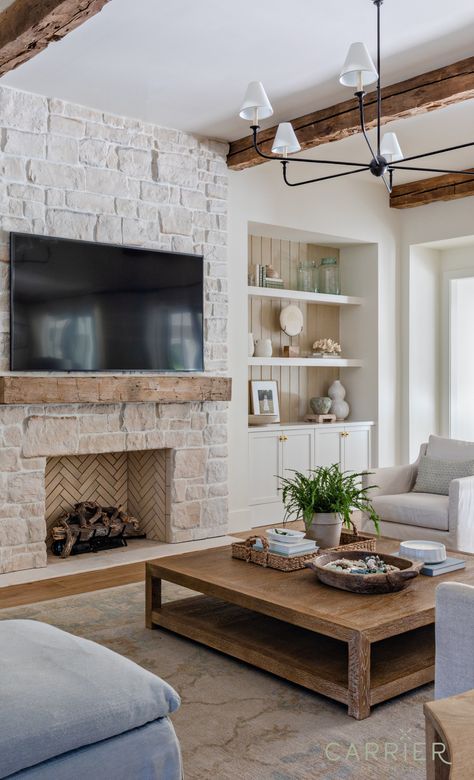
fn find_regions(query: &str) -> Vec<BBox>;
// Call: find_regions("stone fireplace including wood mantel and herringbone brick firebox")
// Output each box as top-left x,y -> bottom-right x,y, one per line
0,375 -> 230,573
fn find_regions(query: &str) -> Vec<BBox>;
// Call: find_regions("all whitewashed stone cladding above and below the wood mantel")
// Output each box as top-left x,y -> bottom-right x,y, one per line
0,88 -> 228,571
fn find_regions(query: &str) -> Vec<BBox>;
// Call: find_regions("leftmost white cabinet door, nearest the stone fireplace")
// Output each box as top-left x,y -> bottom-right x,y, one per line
249,431 -> 282,504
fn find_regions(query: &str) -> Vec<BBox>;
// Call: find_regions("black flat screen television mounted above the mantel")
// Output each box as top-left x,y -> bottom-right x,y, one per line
10,233 -> 203,371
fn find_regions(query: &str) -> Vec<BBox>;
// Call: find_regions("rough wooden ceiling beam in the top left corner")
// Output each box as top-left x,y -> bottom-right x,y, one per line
0,0 -> 109,76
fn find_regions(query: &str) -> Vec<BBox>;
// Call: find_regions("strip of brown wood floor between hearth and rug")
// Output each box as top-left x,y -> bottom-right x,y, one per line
0,561 -> 145,609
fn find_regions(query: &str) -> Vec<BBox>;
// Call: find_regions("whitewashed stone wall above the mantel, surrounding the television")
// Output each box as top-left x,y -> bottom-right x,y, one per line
0,87 -> 228,372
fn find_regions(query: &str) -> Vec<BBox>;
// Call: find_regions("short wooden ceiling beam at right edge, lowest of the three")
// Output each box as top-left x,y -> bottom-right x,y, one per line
390,168 -> 474,209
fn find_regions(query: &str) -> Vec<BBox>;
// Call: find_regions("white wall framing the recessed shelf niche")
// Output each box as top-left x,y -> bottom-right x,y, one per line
228,163 -> 400,528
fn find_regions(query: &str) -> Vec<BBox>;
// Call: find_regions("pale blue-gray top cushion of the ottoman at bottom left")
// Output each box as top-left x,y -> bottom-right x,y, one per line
0,620 -> 180,778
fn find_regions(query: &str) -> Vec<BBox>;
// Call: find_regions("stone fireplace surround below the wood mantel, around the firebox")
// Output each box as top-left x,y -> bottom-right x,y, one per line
0,401 -> 228,572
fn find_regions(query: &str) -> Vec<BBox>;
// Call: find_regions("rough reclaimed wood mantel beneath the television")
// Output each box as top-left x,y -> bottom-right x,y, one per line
0,374 -> 232,404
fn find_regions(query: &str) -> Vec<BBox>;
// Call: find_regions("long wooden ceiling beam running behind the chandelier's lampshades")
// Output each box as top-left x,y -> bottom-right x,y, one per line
227,57 -> 474,170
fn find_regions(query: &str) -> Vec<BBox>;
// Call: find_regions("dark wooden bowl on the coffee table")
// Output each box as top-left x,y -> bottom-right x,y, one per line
306,550 -> 423,594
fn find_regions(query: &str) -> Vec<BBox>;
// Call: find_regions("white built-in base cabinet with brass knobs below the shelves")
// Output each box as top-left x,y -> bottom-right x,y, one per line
249,422 -> 373,525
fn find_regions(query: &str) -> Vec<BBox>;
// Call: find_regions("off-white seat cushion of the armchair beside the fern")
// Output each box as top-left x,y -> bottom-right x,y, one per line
371,493 -> 449,531
